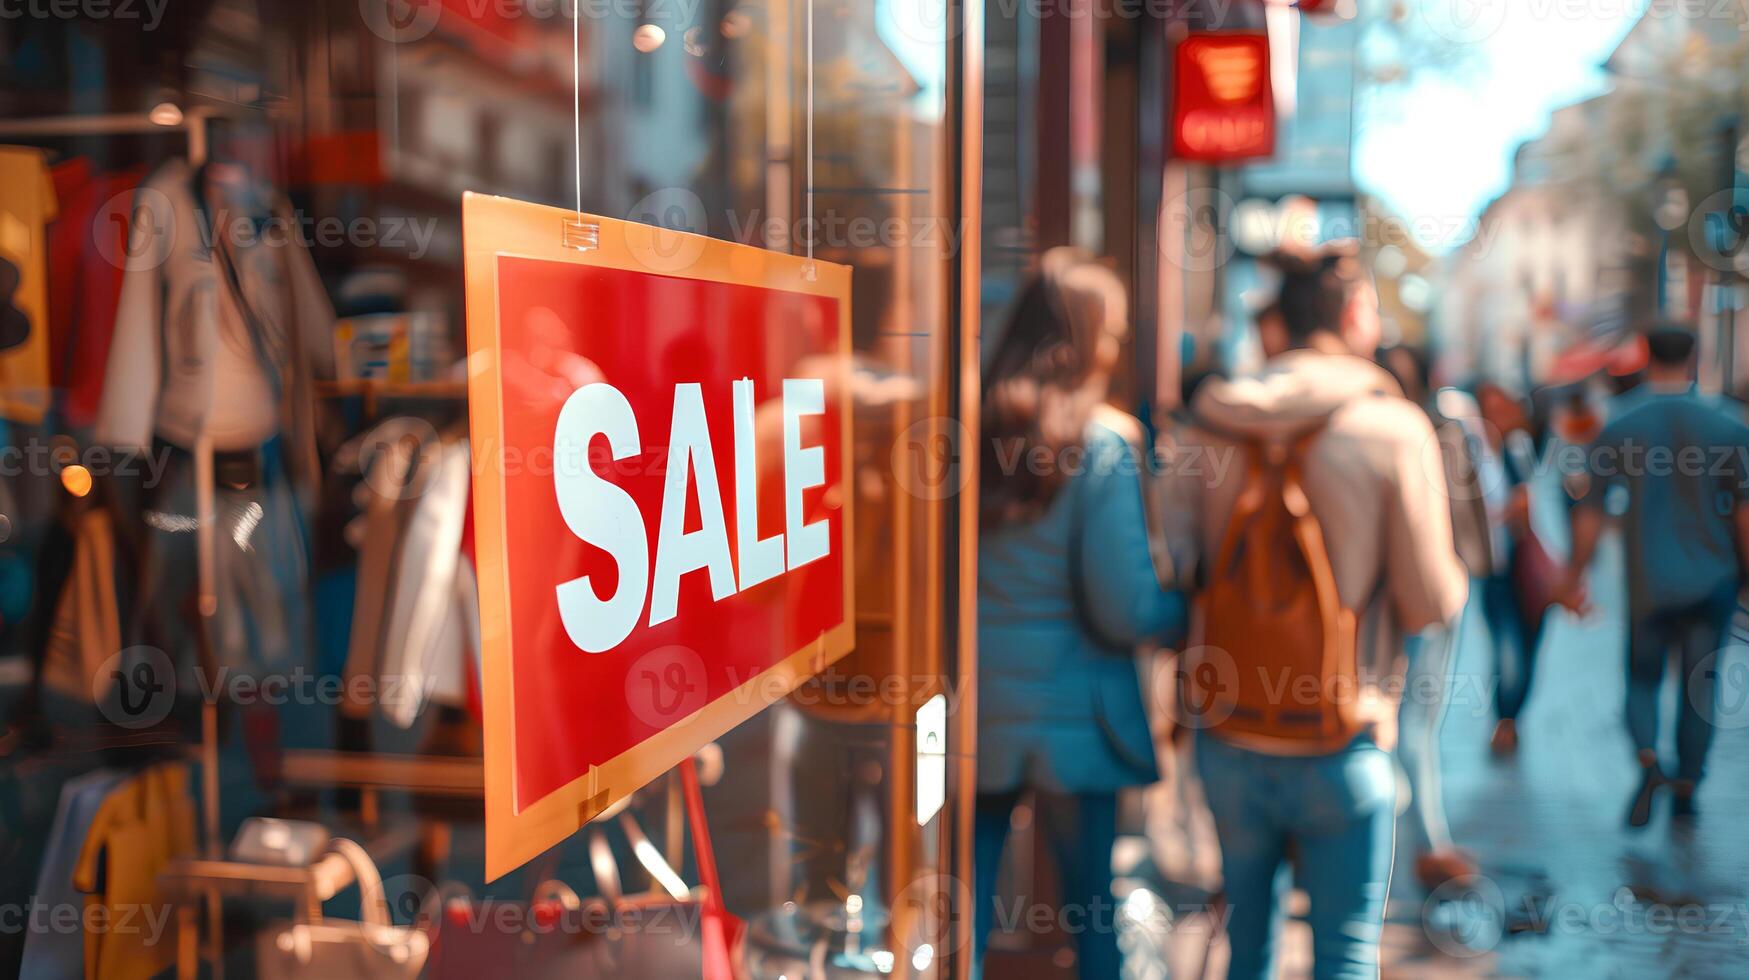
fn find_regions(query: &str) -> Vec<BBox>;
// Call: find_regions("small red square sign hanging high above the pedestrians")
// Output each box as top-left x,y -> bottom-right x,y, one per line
1172,32 -> 1275,163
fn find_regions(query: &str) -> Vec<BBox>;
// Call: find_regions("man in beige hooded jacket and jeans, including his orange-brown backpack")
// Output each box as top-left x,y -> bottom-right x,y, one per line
1184,245 -> 1469,980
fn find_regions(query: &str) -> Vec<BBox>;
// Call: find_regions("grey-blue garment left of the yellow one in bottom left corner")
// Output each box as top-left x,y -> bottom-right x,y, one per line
19,768 -> 128,980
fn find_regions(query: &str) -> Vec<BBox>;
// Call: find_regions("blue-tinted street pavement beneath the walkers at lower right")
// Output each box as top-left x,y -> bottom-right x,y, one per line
1385,541 -> 1749,978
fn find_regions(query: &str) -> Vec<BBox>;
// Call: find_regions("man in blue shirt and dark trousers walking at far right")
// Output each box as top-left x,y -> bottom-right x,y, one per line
1558,324 -> 1749,828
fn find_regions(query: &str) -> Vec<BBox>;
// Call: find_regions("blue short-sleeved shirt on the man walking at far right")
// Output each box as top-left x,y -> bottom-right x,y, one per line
1588,389 -> 1749,614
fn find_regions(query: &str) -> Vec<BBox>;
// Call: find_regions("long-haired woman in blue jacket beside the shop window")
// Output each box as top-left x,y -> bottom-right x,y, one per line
974,249 -> 1184,980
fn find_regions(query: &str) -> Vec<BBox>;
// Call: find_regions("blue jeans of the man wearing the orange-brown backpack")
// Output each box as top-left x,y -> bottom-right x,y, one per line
1196,732 -> 1397,980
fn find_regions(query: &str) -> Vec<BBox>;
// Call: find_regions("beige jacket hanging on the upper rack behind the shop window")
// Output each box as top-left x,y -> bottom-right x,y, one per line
96,159 -> 334,497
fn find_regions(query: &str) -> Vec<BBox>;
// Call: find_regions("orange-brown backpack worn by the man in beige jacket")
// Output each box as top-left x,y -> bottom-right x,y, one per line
1186,431 -> 1362,756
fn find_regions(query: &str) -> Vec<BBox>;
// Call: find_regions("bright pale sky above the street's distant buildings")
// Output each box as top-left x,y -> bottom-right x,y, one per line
1354,0 -> 1644,249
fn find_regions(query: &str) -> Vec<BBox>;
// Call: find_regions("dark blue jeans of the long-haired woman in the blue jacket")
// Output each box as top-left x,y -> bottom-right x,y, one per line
972,789 -> 1123,980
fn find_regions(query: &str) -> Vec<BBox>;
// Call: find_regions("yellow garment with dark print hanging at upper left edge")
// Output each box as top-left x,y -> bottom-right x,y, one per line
0,147 -> 54,424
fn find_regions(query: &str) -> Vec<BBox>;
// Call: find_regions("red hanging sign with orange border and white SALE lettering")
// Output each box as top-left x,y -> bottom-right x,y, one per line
463,194 -> 854,877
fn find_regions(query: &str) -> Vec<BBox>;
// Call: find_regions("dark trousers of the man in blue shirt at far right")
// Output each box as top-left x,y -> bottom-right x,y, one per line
1627,581 -> 1737,782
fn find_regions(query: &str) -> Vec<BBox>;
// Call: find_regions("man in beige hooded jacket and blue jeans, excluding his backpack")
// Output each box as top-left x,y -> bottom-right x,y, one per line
1177,249 -> 1469,980
